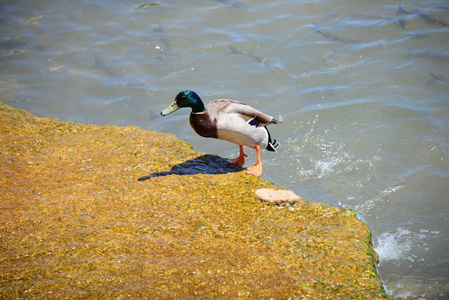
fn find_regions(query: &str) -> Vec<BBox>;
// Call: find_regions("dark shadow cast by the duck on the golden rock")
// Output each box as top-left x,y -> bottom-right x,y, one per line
138,154 -> 243,181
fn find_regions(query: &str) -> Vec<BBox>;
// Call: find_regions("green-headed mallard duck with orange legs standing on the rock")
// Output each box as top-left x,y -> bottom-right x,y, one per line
161,90 -> 281,176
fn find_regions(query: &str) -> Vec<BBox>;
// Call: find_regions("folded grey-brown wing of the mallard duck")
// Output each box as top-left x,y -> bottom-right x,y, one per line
207,99 -> 281,126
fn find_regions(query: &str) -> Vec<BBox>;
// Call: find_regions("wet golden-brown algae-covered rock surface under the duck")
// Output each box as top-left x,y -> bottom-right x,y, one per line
0,104 -> 386,299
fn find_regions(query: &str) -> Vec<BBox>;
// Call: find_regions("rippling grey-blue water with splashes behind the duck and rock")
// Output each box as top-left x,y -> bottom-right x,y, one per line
0,0 -> 449,299
